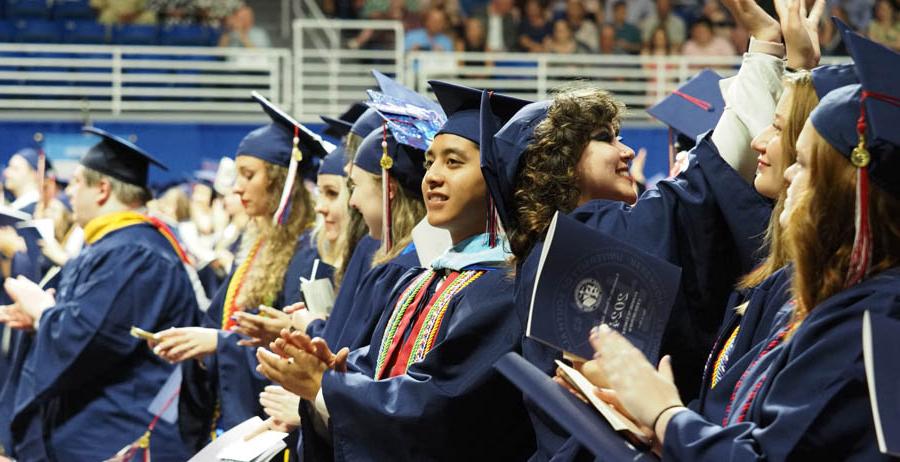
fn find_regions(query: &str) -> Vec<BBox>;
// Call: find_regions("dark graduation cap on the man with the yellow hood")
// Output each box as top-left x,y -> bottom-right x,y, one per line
81,127 -> 169,188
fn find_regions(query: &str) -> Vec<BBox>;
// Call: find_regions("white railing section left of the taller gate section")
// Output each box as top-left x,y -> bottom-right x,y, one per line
0,44 -> 293,121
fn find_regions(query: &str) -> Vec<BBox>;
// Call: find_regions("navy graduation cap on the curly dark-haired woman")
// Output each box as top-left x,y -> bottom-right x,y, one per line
479,91 -> 551,244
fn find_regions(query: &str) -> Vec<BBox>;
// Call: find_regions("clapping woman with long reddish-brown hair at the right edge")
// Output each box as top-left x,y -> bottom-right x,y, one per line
585,27 -> 900,461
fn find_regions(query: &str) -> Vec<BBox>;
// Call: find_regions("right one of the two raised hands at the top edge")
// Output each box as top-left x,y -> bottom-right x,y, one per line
775,0 -> 825,69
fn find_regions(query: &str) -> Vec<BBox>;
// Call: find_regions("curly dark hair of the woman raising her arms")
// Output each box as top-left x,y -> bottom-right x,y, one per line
507,83 -> 624,260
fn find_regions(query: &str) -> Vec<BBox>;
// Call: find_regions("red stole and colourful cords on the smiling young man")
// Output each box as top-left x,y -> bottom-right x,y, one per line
375,269 -> 485,379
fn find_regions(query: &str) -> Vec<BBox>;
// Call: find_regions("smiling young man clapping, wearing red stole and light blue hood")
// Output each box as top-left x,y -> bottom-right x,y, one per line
259,82 -> 533,460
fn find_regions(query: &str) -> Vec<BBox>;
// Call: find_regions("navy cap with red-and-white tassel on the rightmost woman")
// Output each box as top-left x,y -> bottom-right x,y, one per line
810,20 -> 900,286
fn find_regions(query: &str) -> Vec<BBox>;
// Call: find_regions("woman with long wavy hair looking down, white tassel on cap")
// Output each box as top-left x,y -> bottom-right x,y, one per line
151,96 -> 331,447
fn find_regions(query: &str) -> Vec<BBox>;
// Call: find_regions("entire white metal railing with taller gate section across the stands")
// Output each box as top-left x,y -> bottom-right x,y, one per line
0,19 -> 848,123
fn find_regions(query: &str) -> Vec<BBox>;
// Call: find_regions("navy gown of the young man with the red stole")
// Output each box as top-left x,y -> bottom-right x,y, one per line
322,268 -> 533,461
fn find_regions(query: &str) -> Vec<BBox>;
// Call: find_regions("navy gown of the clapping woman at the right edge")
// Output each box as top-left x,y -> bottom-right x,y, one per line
663,268 -> 900,461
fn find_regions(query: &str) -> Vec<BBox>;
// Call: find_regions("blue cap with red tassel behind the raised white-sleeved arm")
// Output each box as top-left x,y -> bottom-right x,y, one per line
647,69 -> 725,140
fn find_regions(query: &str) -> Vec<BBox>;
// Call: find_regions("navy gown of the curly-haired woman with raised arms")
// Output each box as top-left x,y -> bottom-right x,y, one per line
516,133 -> 772,460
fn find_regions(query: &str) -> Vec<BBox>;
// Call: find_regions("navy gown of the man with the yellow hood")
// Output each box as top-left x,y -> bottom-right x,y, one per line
12,220 -> 198,461
